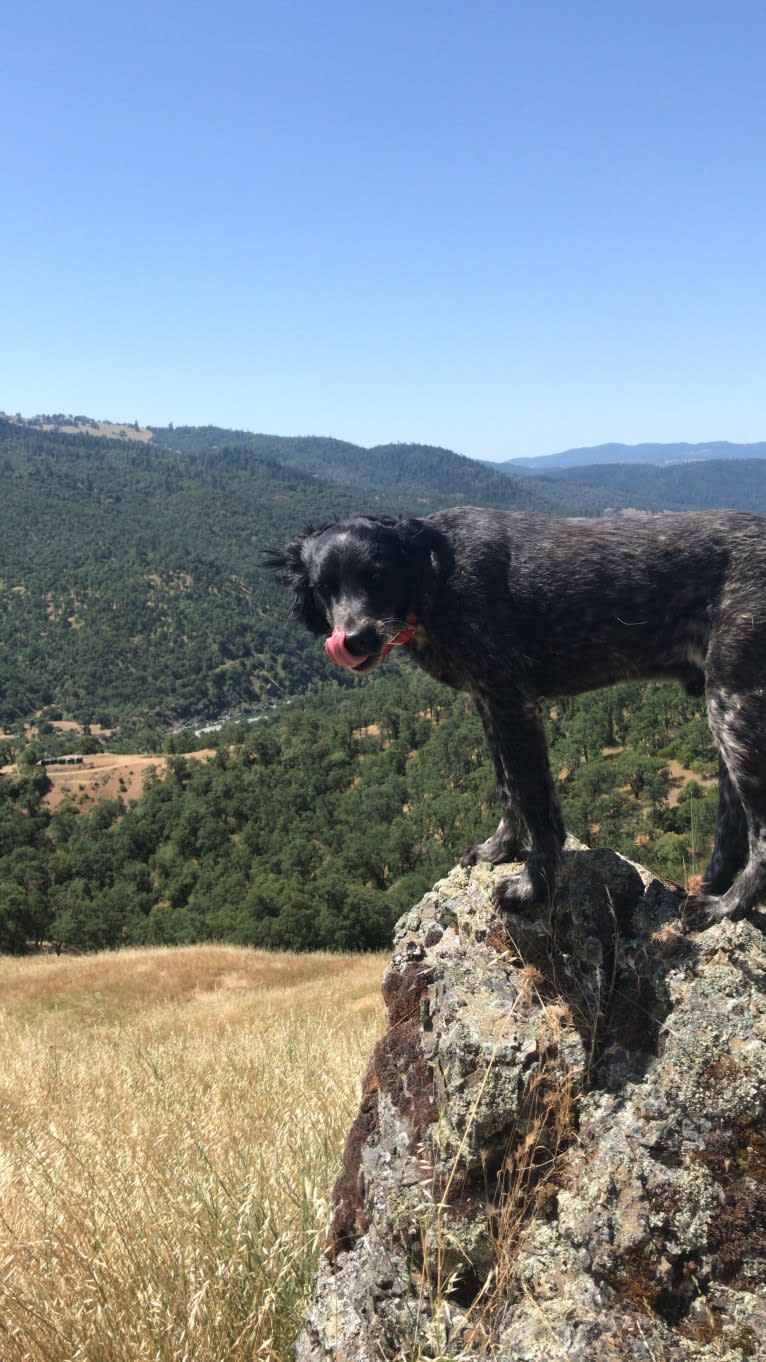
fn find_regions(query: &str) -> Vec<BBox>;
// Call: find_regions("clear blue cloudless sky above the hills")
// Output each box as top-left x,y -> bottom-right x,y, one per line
0,0 -> 766,459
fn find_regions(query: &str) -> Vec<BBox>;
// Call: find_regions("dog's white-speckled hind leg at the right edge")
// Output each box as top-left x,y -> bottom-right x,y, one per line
705,685 -> 766,922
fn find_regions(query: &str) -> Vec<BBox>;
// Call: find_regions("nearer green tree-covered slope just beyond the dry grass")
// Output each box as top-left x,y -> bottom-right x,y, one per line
0,658 -> 716,951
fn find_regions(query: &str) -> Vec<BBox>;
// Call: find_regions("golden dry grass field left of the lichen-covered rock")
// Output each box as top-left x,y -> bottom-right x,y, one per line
0,947 -> 383,1362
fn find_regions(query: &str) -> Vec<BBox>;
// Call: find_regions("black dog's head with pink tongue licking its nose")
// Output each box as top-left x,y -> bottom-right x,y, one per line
266,515 -> 442,676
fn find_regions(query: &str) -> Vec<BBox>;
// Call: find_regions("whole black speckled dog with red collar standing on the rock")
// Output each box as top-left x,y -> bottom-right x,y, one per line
267,507 -> 766,921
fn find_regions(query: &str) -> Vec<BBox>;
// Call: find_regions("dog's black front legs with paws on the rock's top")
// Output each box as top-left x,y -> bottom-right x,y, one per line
463,696 -> 566,910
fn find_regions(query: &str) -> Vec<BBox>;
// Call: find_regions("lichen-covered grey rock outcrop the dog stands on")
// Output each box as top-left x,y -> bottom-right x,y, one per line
297,849 -> 766,1362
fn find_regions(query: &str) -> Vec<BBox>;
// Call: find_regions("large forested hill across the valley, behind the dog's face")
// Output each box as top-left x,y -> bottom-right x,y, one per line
0,421 -> 561,731
